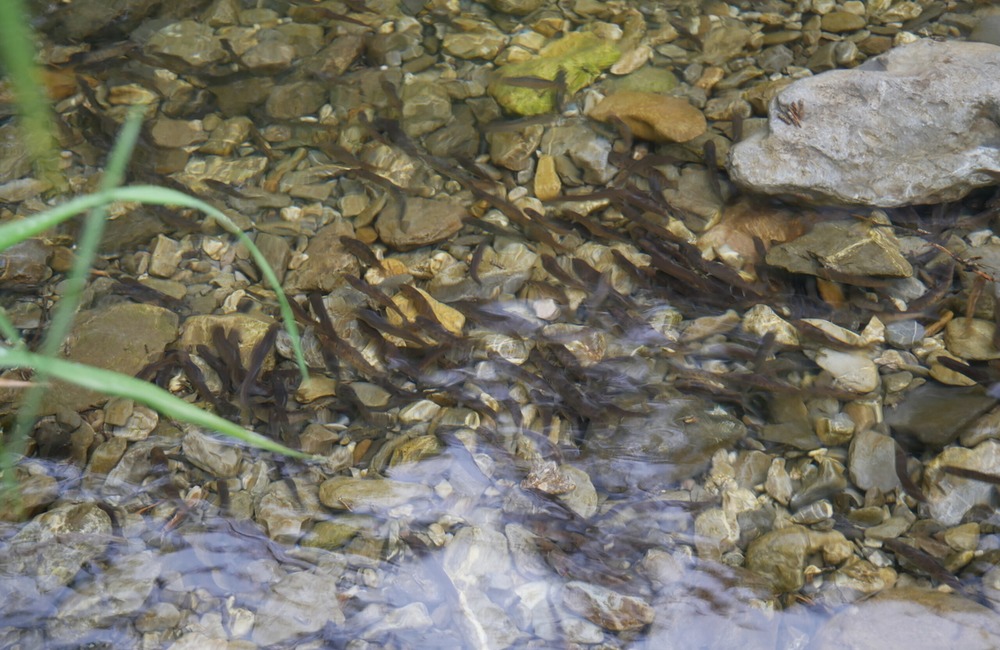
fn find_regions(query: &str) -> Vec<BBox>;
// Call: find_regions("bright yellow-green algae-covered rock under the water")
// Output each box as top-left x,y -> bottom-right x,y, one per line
488,32 -> 621,115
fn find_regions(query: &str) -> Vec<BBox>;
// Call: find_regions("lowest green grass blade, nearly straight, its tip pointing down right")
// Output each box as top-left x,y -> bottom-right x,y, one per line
0,348 -> 310,458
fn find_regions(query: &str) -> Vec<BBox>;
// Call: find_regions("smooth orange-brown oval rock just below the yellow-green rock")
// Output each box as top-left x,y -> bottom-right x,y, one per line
590,91 -> 706,142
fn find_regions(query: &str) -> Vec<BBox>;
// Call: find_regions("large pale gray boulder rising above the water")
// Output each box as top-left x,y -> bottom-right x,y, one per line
729,40 -> 1000,207
